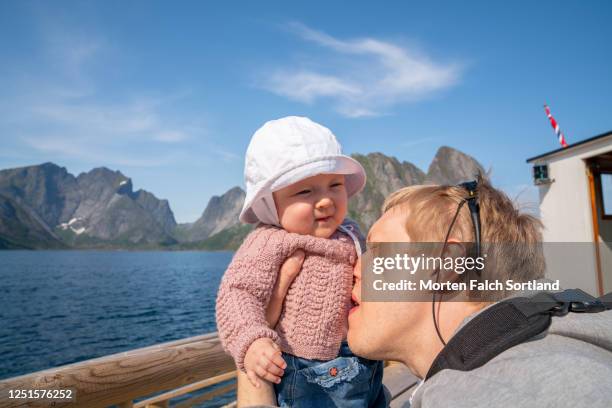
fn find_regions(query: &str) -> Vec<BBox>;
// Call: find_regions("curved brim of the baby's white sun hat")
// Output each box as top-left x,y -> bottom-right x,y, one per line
240,155 -> 366,224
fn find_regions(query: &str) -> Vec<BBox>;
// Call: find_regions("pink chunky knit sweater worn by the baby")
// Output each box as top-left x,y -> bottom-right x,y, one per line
216,224 -> 358,370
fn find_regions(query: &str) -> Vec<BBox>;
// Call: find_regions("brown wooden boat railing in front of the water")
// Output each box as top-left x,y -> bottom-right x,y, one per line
0,333 -> 415,408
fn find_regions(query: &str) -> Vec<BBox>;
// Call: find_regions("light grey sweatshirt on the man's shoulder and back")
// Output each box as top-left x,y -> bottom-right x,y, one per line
414,311 -> 612,408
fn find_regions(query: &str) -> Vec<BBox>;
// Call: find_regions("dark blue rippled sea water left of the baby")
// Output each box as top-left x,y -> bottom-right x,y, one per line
0,251 -> 233,404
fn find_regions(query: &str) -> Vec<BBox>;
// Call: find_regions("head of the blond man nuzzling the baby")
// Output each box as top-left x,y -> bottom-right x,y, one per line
348,180 -> 544,375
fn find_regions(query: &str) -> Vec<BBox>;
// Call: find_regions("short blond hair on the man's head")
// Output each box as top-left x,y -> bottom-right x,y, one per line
382,176 -> 545,294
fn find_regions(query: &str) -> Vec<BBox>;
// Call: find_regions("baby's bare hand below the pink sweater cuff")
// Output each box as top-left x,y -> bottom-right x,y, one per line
244,337 -> 287,388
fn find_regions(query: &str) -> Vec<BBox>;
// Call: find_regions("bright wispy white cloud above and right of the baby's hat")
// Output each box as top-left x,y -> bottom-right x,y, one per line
259,23 -> 462,117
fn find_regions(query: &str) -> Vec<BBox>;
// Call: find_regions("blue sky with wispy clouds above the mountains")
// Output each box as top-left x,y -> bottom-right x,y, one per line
0,0 -> 612,222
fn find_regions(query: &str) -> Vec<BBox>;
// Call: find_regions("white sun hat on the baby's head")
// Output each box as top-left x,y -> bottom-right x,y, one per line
240,116 -> 366,226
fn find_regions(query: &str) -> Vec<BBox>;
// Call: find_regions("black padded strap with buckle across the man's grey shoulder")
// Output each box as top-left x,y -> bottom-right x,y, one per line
425,289 -> 612,380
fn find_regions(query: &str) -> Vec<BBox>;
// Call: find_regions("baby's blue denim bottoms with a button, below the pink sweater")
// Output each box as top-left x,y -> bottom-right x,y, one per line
274,341 -> 387,408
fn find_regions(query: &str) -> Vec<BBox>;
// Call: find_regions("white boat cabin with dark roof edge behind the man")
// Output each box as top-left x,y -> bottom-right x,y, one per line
527,131 -> 612,296
